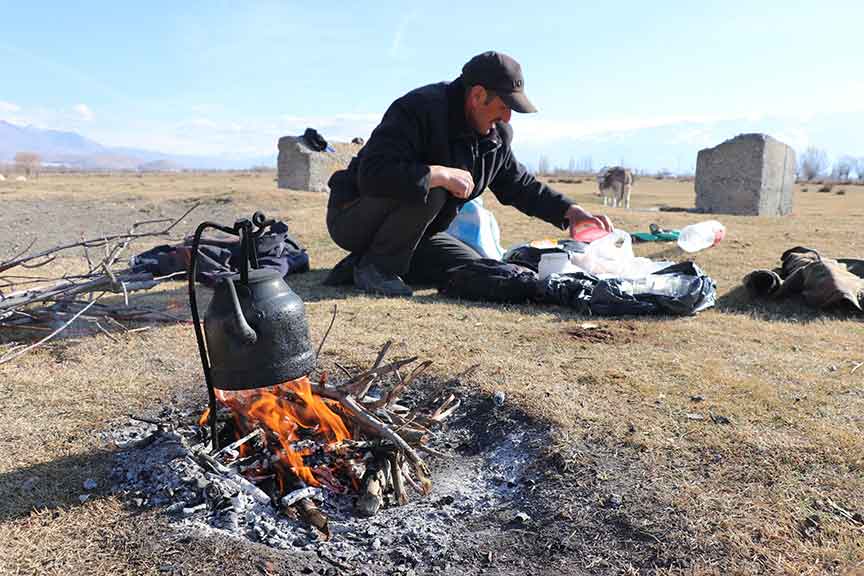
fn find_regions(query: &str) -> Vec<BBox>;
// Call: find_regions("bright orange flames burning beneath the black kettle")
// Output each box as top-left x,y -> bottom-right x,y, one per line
211,376 -> 351,492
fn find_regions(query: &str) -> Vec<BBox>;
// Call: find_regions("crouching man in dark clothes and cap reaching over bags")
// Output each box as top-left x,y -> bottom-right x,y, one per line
325,52 -> 612,296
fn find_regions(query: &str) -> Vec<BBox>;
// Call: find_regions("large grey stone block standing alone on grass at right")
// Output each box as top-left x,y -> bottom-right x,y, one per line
696,134 -> 796,216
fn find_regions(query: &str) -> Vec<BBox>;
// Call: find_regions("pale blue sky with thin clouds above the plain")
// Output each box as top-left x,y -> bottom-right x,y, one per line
0,0 -> 864,170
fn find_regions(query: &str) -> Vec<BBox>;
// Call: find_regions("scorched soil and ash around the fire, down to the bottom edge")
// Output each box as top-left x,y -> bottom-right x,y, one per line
105,382 -> 695,575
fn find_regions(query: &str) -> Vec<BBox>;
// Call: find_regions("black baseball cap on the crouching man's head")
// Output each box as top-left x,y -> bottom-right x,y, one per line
462,50 -> 537,112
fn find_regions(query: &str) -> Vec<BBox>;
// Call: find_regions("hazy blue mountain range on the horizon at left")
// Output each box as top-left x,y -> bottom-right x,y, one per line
0,120 -> 276,171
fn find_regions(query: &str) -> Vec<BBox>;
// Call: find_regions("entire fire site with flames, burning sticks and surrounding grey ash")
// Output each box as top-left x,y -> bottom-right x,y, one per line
109,356 -> 545,574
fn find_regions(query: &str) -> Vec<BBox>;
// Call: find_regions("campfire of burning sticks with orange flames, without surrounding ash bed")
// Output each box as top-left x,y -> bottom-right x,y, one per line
188,342 -> 460,539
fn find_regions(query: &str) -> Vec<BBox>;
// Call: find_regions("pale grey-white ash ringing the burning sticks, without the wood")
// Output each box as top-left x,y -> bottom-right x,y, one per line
106,401 -> 548,571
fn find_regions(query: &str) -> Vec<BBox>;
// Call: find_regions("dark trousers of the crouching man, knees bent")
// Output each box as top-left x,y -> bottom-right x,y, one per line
327,188 -> 482,284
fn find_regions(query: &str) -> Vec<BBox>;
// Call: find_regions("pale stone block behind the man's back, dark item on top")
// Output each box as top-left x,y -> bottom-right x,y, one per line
277,136 -> 360,192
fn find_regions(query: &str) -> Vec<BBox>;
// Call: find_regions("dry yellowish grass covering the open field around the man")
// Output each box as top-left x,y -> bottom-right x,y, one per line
0,174 -> 864,574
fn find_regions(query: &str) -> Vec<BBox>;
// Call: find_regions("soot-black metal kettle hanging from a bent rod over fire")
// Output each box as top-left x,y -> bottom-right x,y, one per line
189,212 -> 316,446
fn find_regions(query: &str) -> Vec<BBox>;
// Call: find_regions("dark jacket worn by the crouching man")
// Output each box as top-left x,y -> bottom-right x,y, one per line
330,77 -> 572,236
